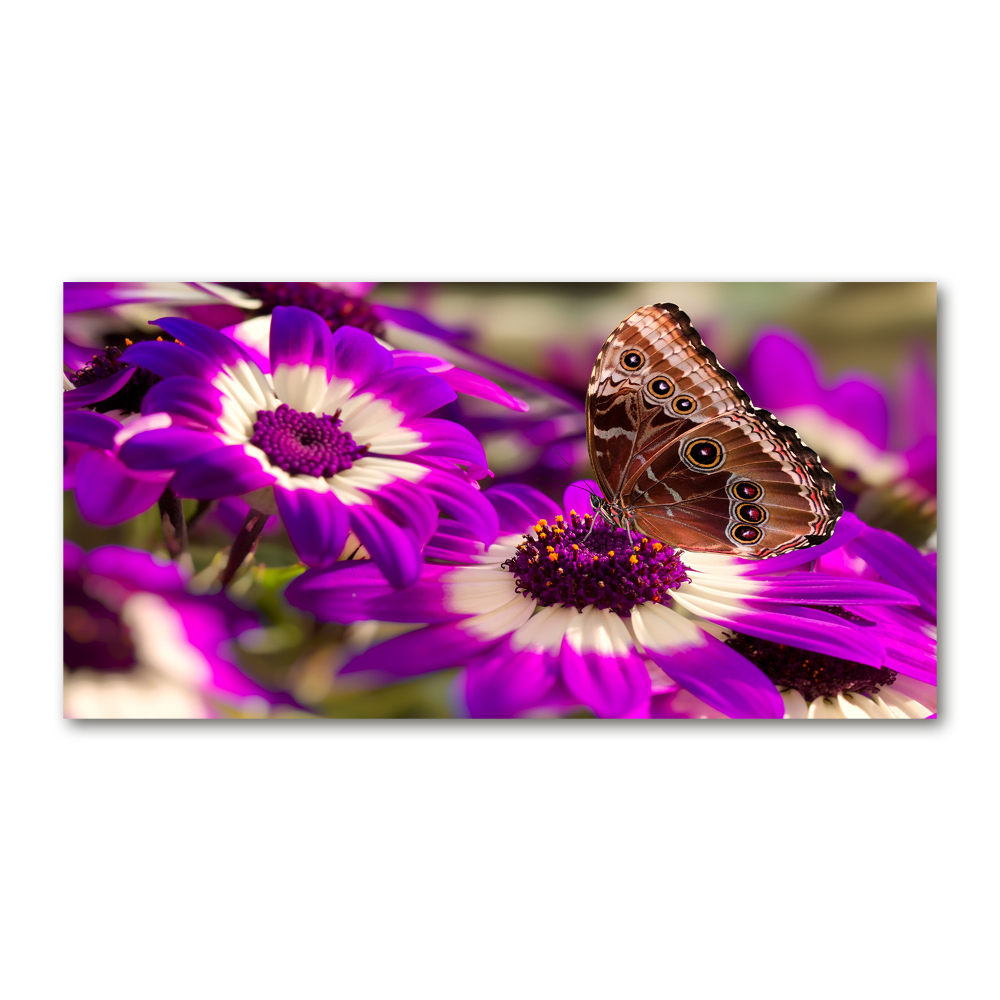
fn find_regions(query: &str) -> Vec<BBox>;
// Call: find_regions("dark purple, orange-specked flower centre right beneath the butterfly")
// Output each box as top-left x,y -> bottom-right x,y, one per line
503,511 -> 688,615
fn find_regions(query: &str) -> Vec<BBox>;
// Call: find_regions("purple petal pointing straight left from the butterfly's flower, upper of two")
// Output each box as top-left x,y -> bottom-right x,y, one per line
285,560 -> 454,625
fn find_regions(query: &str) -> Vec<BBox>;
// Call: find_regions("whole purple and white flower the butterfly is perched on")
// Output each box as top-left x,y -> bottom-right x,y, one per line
286,483 -> 915,718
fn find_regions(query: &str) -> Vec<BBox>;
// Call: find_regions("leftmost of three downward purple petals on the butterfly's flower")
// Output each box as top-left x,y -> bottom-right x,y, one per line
463,642 -> 559,719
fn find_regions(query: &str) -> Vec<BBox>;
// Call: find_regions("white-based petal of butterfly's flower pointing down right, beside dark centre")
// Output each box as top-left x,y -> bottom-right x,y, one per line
632,607 -> 785,719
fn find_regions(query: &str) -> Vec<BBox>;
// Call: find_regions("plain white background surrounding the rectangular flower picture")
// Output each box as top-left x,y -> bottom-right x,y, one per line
7,0 -> 1000,998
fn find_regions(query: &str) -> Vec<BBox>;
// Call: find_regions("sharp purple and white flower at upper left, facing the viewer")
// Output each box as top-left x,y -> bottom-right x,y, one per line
119,306 -> 497,586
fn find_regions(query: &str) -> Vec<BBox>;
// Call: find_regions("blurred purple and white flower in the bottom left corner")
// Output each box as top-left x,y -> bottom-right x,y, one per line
63,542 -> 294,719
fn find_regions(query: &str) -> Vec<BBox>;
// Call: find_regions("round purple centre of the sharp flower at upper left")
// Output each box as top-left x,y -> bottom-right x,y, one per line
250,403 -> 368,479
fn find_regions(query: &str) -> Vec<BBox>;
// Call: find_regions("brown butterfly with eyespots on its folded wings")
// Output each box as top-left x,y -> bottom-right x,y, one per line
587,303 -> 844,558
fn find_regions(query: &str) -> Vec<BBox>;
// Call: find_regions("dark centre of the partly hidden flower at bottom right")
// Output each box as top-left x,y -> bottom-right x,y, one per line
728,608 -> 896,701
